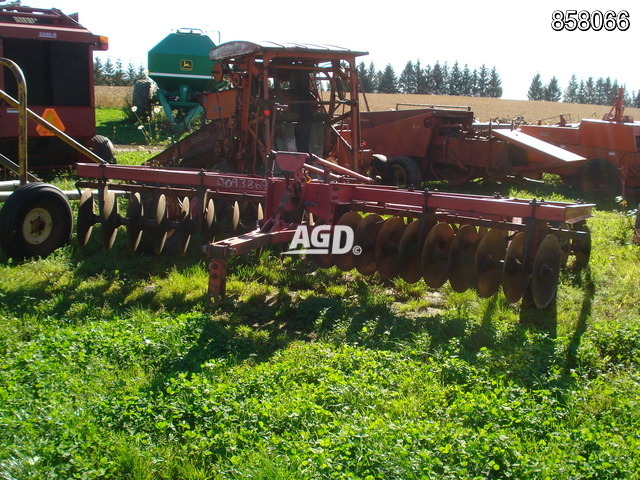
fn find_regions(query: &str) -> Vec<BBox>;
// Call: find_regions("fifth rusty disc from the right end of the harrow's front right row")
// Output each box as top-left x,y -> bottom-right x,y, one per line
421,222 -> 455,288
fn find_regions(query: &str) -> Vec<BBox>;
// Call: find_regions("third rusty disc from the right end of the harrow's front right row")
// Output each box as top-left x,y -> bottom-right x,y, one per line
474,229 -> 507,298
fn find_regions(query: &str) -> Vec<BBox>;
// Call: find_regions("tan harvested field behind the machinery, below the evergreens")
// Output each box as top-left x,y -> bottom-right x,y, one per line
95,86 -> 640,123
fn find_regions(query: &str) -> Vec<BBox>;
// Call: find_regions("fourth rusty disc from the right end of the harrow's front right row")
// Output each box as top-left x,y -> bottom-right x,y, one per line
448,225 -> 480,292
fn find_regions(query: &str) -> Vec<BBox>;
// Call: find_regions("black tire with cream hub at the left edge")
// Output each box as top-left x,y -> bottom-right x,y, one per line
0,182 -> 73,259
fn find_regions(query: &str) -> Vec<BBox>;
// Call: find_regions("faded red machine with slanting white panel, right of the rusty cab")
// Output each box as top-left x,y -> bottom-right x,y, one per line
361,106 -> 584,185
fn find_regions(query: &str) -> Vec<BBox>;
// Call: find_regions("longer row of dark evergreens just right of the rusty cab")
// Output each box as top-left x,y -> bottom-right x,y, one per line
356,60 -> 502,98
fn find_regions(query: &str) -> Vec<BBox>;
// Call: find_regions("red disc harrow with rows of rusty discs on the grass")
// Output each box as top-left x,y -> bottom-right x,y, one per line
77,152 -> 592,308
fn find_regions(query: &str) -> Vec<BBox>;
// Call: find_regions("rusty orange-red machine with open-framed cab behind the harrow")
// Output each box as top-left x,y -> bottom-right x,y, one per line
149,41 -> 371,178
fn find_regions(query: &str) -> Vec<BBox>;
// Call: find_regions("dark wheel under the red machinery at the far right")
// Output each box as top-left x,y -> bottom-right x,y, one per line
576,159 -> 622,203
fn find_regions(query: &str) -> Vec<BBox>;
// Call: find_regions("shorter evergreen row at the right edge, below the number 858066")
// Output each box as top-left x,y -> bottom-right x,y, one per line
527,73 -> 640,107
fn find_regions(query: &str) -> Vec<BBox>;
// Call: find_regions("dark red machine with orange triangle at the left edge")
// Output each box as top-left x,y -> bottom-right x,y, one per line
0,4 -> 113,169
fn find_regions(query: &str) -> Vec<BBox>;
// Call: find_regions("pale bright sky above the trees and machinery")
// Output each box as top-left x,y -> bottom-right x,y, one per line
17,0 -> 640,99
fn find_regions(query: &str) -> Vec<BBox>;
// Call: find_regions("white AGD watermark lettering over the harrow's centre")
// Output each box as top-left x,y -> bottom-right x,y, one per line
283,225 -> 362,255
